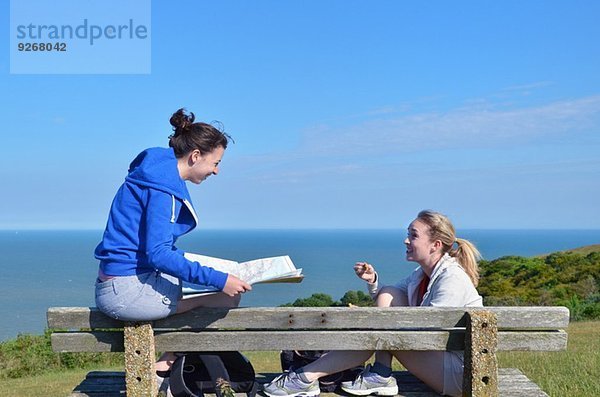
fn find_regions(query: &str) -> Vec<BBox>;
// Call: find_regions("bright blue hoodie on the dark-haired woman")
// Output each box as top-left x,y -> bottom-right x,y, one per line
95,148 -> 227,290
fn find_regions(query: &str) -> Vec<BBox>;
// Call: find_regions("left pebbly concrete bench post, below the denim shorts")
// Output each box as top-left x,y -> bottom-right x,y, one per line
124,323 -> 157,397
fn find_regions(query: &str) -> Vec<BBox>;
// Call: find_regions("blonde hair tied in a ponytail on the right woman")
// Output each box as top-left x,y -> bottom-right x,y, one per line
417,210 -> 481,287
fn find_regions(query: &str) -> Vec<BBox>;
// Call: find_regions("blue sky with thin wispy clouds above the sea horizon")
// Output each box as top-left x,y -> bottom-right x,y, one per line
0,0 -> 600,229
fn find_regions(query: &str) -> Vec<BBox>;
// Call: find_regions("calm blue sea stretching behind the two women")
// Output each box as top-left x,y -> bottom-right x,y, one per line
0,230 -> 600,341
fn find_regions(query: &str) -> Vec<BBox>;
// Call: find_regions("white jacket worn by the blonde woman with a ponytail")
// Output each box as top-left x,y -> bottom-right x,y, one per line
367,253 -> 483,307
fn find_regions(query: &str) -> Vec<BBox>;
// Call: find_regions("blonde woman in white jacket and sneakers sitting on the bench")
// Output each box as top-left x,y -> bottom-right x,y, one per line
264,211 -> 482,397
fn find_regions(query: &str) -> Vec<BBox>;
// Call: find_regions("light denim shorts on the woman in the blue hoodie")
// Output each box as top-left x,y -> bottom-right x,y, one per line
96,271 -> 182,321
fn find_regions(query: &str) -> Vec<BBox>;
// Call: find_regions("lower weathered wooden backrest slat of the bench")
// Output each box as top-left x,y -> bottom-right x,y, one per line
52,330 -> 567,352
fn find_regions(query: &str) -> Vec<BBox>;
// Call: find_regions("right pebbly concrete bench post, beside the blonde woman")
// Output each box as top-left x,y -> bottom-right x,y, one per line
463,310 -> 498,397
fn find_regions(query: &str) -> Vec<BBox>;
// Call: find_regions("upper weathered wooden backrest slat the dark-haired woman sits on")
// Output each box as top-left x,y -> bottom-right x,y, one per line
48,307 -> 569,330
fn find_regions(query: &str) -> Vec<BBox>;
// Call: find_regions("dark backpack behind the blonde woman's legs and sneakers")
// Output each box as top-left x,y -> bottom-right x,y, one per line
279,350 -> 364,393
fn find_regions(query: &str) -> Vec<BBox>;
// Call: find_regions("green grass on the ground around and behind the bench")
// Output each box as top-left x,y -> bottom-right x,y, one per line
0,321 -> 600,397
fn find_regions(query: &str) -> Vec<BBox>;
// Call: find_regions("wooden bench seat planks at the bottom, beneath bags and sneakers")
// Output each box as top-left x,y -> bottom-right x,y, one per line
71,368 -> 548,397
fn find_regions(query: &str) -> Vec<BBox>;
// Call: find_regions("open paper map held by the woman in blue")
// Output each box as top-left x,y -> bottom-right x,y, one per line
183,252 -> 304,299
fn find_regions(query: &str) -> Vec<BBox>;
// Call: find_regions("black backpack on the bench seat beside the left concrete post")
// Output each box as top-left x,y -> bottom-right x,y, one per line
169,352 -> 258,397
